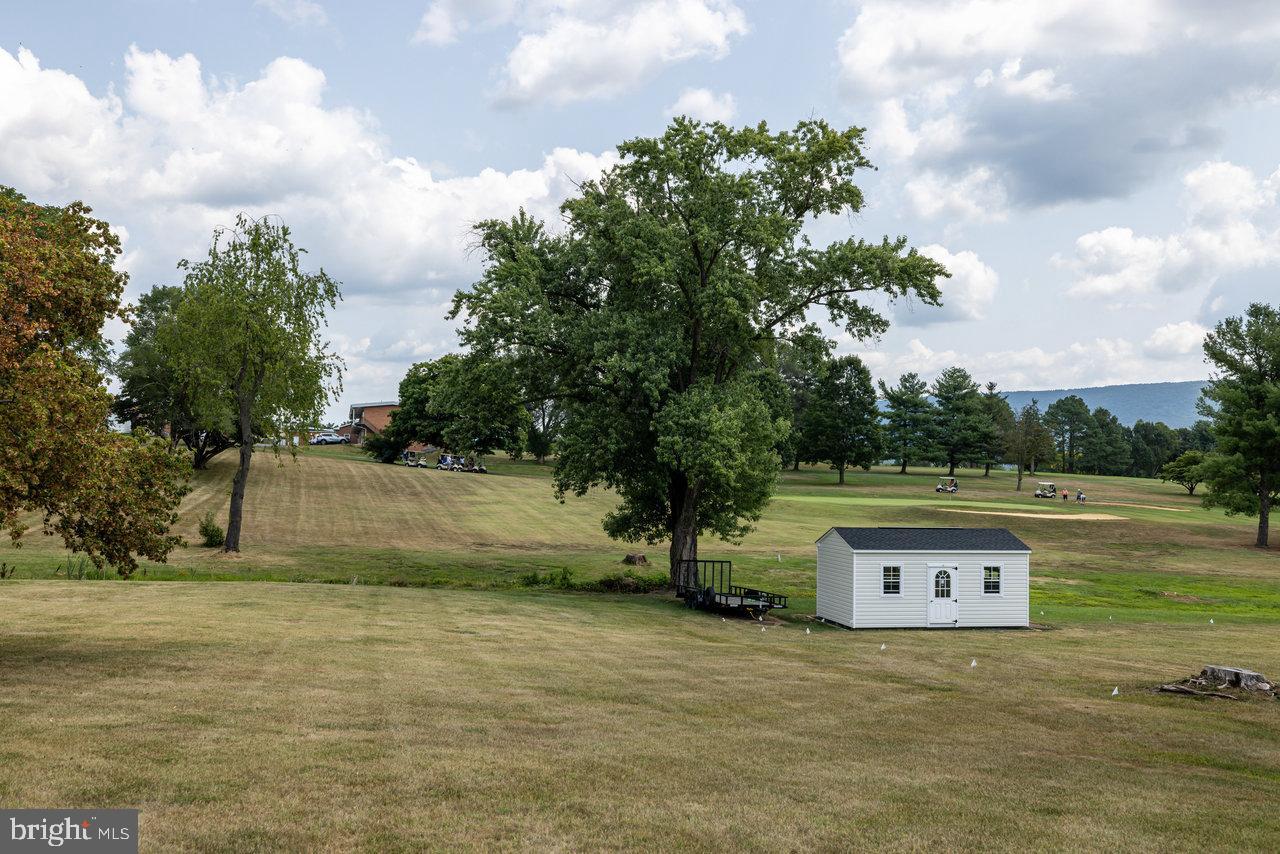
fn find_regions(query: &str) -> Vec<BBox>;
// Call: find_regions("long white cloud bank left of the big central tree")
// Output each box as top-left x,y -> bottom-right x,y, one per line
0,47 -> 616,297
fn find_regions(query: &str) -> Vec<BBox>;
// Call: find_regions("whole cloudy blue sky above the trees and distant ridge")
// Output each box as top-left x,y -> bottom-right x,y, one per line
0,0 -> 1280,421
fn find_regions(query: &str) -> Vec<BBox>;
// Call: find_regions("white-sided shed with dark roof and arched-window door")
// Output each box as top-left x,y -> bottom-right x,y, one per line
818,528 -> 1032,629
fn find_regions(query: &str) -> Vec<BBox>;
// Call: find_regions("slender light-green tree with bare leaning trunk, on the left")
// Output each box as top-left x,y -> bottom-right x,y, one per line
178,214 -> 342,552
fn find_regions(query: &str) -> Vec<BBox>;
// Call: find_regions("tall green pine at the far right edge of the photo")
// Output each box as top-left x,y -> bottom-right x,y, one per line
1199,302 -> 1280,548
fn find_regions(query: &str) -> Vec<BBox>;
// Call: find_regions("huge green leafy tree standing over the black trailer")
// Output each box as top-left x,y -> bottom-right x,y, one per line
453,119 -> 946,574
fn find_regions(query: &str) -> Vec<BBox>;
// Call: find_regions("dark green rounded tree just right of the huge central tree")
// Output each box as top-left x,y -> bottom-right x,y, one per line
803,356 -> 881,484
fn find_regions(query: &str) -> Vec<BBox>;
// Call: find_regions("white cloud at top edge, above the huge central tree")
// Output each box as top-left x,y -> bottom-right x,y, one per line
412,0 -> 748,104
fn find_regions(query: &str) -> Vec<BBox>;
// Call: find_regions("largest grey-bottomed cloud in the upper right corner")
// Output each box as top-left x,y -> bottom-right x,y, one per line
837,0 -> 1280,206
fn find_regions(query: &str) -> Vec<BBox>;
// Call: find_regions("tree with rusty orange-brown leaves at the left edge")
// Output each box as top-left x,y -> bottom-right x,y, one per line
0,187 -> 189,575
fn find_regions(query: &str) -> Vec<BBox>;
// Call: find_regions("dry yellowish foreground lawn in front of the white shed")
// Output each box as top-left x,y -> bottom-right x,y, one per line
0,581 -> 1280,851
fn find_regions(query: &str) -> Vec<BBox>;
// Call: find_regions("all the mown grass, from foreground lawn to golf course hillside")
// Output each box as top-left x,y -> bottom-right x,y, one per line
0,448 -> 1280,851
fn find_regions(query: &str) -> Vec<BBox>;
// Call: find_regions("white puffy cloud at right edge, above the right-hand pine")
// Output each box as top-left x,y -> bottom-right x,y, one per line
1053,161 -> 1280,296
